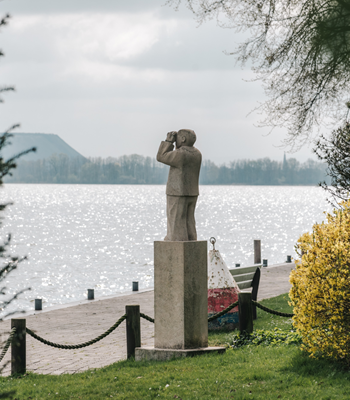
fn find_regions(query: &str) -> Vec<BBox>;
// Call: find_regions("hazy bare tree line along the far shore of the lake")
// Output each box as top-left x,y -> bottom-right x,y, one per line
5,154 -> 327,185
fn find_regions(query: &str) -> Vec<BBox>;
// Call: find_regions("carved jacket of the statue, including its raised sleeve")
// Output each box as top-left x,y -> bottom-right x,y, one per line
157,142 -> 202,196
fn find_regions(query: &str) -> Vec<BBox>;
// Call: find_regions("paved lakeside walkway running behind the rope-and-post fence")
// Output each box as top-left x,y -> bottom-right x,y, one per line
0,264 -> 294,375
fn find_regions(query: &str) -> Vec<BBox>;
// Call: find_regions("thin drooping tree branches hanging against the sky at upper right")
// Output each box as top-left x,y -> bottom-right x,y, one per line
167,0 -> 350,146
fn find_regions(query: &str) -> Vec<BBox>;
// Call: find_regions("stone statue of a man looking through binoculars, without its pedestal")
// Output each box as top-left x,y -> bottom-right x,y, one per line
157,129 -> 202,242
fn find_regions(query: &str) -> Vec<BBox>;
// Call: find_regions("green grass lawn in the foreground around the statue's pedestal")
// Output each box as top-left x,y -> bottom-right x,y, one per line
0,295 -> 350,400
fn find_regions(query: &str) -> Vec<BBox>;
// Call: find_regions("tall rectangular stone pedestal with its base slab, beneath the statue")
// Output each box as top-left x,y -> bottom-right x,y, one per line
135,241 -> 225,360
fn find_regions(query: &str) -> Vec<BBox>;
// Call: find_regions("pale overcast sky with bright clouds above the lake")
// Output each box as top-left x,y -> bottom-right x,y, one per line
0,0 -> 314,164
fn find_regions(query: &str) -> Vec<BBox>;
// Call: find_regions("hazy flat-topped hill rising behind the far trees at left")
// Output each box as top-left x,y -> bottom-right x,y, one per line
2,133 -> 85,161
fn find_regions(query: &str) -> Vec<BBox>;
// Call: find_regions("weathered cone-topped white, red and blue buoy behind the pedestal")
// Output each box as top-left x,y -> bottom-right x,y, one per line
208,238 -> 240,330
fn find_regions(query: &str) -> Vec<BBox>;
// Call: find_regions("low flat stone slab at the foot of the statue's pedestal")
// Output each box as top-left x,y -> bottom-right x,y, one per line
135,346 -> 226,361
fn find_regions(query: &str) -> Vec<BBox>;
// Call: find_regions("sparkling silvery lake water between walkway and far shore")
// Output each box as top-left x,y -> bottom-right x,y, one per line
0,184 -> 330,316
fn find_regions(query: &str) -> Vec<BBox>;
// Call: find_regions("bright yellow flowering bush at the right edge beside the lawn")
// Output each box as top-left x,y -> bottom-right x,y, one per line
289,201 -> 350,364
